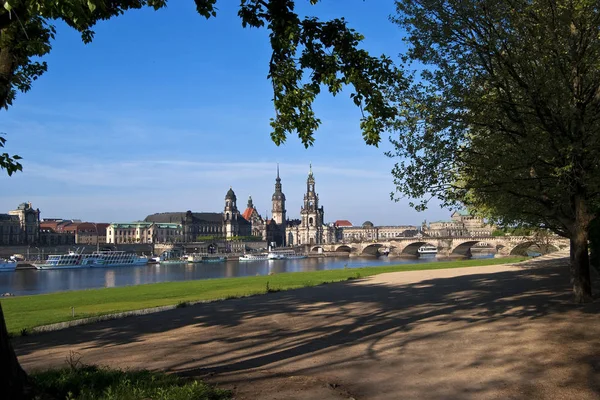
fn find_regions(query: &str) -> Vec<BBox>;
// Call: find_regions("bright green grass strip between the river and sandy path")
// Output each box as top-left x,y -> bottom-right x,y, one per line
2,257 -> 525,335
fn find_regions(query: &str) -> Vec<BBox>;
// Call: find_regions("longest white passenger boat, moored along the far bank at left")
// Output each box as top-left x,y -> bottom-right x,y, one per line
33,251 -> 148,269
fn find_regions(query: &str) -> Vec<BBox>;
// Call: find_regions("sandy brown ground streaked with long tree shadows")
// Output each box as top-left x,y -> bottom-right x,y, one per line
15,259 -> 600,400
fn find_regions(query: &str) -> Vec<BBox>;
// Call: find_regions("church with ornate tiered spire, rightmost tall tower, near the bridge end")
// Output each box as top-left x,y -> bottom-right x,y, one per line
286,165 -> 336,246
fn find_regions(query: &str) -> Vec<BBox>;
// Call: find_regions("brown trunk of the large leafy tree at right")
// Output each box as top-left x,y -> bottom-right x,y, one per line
570,196 -> 592,303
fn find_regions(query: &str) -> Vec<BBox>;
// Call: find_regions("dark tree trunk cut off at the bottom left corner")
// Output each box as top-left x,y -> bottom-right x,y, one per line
0,305 -> 31,400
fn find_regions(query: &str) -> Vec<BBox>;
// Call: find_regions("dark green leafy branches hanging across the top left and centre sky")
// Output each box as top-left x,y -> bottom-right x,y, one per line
0,0 -> 404,167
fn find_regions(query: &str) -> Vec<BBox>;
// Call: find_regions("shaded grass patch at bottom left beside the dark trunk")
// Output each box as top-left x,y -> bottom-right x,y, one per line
31,365 -> 231,400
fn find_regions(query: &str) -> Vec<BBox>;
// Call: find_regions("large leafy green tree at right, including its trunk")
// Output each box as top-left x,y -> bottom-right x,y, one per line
388,0 -> 600,302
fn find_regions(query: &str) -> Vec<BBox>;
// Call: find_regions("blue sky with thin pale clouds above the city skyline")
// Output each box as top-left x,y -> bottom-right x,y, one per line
0,0 -> 450,225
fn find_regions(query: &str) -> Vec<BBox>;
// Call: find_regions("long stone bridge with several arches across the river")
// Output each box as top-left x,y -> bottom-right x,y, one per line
311,236 -> 569,258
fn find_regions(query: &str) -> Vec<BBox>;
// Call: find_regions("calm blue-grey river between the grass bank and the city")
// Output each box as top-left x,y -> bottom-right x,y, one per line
0,255 -> 493,296
